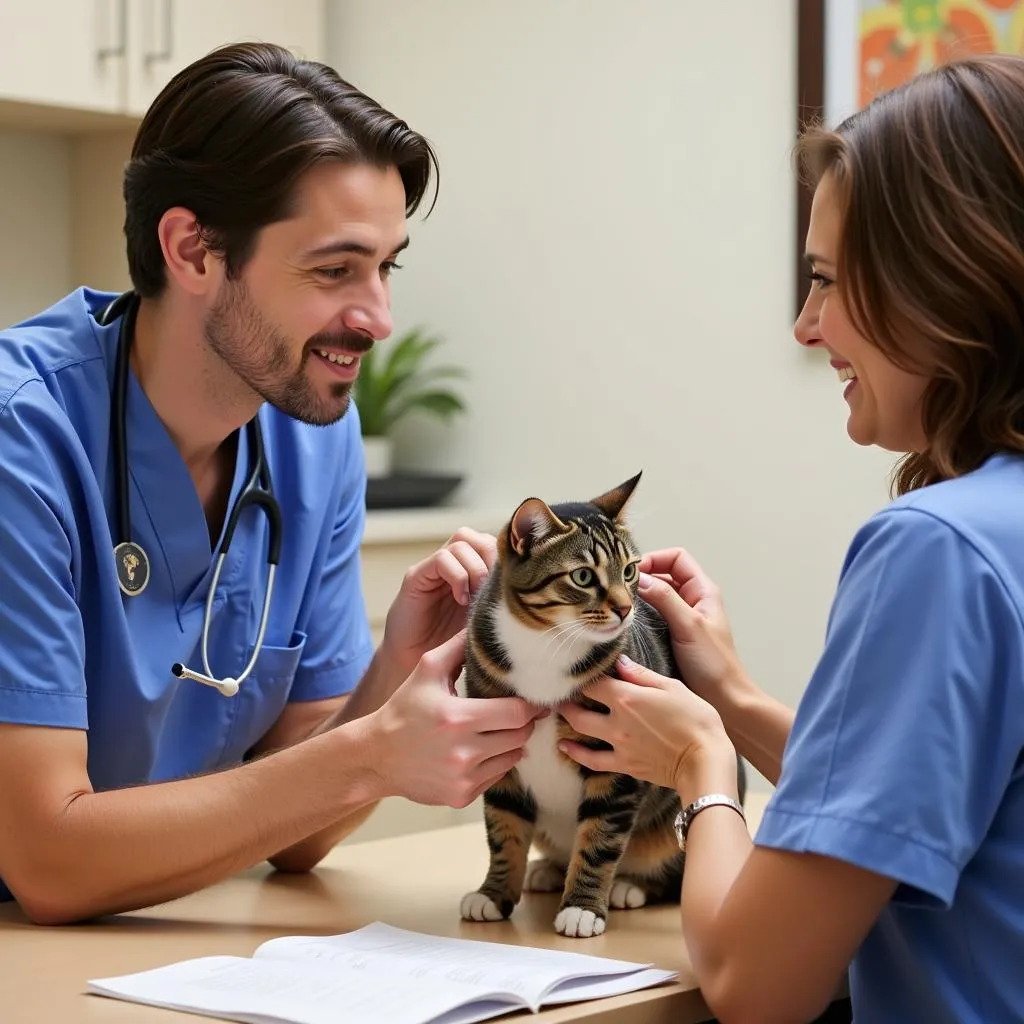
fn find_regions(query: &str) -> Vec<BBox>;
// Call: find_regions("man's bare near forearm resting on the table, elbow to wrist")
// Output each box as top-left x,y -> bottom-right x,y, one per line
14,724 -> 380,924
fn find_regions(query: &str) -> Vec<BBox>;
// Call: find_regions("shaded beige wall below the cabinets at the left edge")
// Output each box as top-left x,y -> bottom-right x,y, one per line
0,130 -> 72,327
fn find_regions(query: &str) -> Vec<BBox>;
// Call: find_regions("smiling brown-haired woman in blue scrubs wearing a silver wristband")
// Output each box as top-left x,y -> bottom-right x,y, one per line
565,55 -> 1024,1024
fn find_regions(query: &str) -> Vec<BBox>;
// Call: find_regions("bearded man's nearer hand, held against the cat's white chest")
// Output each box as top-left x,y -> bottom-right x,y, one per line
361,631 -> 550,807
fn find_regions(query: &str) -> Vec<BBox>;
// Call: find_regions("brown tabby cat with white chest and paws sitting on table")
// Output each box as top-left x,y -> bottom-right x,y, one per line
460,473 -> 746,937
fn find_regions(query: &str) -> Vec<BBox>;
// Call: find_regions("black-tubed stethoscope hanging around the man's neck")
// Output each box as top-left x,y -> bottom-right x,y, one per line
96,291 -> 282,697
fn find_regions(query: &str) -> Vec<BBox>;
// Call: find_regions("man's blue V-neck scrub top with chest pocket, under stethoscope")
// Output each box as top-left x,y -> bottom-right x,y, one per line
0,289 -> 373,898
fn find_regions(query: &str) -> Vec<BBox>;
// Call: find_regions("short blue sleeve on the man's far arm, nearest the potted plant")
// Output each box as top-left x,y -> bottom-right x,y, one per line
289,406 -> 374,700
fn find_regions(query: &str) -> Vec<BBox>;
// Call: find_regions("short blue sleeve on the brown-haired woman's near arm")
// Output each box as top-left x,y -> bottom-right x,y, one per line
757,507 -> 1024,906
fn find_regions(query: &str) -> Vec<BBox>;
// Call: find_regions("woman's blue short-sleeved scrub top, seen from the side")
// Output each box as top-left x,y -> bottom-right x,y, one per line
757,455 -> 1024,1024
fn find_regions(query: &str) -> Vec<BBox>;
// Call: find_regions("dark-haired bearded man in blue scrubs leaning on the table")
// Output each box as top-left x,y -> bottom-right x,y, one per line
0,39 -> 532,923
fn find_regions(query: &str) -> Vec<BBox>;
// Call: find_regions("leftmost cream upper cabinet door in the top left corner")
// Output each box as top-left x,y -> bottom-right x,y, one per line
0,0 -> 128,113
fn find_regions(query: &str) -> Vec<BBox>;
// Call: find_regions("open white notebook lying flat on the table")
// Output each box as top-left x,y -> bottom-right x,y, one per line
88,923 -> 676,1024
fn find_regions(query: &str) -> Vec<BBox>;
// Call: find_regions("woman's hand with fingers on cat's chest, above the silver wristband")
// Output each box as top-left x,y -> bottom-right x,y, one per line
557,656 -> 736,790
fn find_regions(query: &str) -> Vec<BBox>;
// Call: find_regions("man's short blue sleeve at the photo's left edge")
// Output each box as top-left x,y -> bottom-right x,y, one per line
0,381 -> 87,729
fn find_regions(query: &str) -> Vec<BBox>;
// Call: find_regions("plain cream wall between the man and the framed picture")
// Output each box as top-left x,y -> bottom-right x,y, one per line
328,0 -> 892,774
